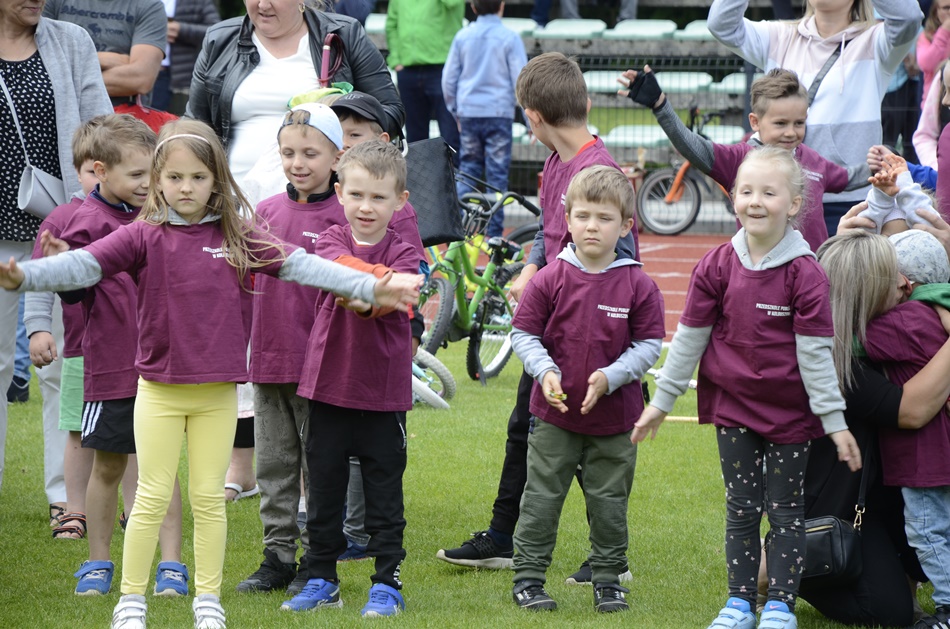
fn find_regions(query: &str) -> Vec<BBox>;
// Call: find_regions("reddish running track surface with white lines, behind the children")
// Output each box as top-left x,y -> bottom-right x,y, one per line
639,233 -> 732,341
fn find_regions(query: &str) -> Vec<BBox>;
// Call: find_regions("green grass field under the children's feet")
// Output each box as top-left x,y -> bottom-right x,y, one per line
0,343 -> 926,629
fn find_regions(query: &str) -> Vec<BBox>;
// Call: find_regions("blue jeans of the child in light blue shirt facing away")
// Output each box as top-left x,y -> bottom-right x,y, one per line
457,118 -> 511,238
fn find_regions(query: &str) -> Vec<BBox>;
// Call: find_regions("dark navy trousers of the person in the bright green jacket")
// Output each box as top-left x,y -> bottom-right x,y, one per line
396,65 -> 459,166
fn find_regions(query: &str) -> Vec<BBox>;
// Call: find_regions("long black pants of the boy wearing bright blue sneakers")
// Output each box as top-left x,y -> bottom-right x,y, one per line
306,402 -> 406,589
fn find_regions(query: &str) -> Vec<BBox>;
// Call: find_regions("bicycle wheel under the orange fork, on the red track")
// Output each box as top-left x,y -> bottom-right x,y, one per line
637,168 -> 701,236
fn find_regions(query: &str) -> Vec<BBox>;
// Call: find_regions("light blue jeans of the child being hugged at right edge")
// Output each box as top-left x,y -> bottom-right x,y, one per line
901,486 -> 950,605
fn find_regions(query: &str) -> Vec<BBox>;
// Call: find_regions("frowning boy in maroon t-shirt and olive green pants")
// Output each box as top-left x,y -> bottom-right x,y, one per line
511,166 -> 666,612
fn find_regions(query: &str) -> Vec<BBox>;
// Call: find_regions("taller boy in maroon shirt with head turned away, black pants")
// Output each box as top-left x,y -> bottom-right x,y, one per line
436,52 -> 639,584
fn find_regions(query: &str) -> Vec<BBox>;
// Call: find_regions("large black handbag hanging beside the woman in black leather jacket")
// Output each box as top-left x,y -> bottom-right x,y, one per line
406,138 -> 465,247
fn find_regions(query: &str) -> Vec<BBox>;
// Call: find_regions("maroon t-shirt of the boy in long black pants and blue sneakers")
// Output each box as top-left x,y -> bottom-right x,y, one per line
297,224 -> 419,411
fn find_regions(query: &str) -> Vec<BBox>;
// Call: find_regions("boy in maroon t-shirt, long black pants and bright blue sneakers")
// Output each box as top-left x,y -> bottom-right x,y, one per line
282,141 -> 419,617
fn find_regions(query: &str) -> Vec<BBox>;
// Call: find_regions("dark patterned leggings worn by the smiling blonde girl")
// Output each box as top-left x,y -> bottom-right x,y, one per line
716,427 -> 811,610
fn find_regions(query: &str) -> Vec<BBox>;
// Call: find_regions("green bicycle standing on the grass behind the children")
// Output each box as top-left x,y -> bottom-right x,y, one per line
419,191 -> 541,384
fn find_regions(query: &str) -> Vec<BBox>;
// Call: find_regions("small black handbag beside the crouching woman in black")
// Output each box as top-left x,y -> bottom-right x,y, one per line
802,442 -> 874,587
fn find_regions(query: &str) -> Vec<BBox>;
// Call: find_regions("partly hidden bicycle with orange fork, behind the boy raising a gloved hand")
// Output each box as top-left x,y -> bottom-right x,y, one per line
637,103 -> 742,236
